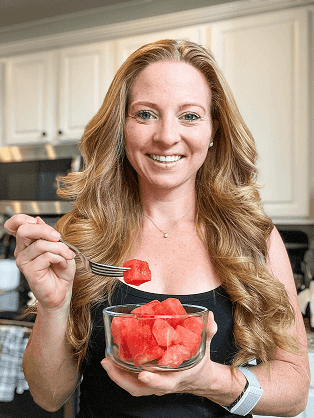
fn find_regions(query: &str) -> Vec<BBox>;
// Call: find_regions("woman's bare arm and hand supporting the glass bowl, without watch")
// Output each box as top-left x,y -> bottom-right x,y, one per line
102,229 -> 310,416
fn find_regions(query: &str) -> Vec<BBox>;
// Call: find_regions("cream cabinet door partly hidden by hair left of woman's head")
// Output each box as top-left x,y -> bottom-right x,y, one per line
56,42 -> 114,140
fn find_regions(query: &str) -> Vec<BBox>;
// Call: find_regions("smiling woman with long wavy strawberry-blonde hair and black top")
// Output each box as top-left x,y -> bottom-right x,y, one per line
5,40 -> 310,418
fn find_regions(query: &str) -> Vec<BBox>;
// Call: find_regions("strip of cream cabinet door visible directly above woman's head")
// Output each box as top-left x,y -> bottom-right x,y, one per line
117,27 -> 205,68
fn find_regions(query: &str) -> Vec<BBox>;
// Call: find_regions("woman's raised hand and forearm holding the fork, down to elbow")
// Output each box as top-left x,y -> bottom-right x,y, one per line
5,215 -> 79,411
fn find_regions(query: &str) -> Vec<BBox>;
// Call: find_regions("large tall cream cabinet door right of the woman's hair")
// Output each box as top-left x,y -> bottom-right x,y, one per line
211,8 -> 309,218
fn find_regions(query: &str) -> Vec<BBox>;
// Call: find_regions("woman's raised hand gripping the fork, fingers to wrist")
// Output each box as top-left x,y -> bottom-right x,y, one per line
4,214 -> 76,312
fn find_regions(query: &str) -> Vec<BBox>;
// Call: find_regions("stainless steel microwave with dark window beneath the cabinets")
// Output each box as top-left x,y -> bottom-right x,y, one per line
0,143 -> 82,215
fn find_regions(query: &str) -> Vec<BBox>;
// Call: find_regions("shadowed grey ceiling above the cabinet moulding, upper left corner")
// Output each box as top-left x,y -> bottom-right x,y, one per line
0,0 -> 141,27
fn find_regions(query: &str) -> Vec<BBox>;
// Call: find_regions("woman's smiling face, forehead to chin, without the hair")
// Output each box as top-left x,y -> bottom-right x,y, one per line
125,61 -> 212,190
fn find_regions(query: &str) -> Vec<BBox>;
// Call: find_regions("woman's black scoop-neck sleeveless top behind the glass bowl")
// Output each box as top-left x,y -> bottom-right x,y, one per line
77,282 -> 251,418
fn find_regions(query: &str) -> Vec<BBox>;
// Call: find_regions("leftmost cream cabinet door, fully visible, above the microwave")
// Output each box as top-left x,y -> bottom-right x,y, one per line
5,52 -> 56,144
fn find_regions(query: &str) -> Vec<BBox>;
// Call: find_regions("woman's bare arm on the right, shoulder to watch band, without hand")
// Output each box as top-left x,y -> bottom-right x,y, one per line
248,228 -> 311,416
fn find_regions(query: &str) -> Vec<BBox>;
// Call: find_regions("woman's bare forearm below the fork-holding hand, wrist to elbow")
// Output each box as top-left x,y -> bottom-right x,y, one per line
23,304 -> 80,412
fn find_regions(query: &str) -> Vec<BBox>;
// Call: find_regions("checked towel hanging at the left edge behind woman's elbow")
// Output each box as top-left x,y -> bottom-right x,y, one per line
0,326 -> 28,402
